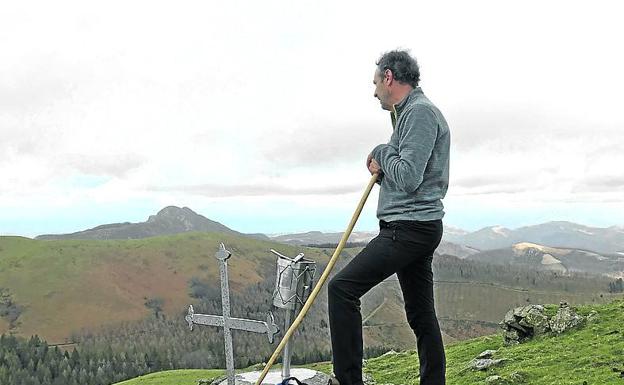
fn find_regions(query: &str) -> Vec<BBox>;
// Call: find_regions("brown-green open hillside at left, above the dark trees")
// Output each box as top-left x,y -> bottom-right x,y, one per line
0,233 -> 329,343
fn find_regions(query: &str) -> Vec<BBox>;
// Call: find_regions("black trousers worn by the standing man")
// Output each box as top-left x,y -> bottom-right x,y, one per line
328,220 -> 446,385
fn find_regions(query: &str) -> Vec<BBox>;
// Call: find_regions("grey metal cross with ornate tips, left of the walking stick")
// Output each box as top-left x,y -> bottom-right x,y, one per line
184,243 -> 279,385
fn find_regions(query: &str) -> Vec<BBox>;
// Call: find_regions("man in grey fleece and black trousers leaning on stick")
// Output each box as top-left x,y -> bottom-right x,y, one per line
328,51 -> 450,385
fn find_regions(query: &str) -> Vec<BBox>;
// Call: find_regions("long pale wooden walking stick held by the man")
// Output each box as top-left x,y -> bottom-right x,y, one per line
255,174 -> 378,385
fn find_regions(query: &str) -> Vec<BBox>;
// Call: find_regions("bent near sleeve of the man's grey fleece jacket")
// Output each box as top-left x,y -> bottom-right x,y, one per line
372,105 -> 438,192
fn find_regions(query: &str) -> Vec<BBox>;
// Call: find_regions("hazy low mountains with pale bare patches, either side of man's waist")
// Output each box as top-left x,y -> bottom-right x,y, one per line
272,226 -> 624,278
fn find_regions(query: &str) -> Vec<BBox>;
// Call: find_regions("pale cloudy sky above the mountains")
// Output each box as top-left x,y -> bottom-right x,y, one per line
0,1 -> 624,236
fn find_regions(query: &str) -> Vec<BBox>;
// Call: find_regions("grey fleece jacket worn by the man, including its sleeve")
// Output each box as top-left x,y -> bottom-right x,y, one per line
372,87 -> 451,222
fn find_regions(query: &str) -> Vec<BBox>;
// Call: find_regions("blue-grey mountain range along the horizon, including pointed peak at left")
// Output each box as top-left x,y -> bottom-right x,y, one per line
36,206 -> 624,258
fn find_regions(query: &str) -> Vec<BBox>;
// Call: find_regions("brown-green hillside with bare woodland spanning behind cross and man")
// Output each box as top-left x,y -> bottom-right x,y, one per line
0,233 -> 612,384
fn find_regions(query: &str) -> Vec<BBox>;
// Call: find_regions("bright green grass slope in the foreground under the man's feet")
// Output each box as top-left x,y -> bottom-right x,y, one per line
120,300 -> 624,385
